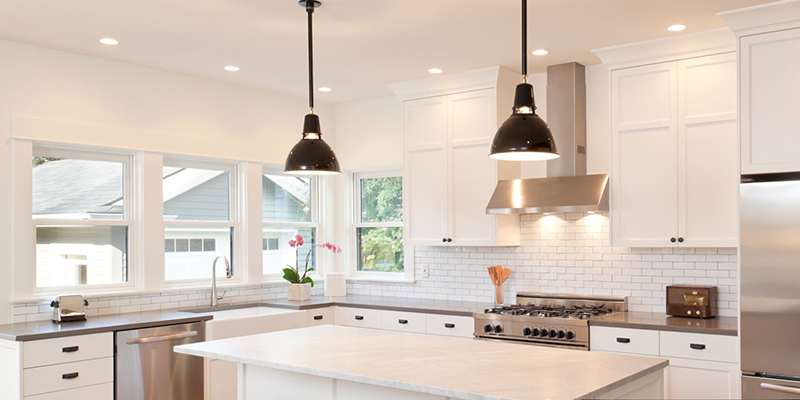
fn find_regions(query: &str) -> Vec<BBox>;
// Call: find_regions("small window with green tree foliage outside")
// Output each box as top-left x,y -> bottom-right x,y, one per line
354,171 -> 405,273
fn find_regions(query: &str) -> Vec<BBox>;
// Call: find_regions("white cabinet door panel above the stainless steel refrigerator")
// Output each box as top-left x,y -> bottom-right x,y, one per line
739,29 -> 800,174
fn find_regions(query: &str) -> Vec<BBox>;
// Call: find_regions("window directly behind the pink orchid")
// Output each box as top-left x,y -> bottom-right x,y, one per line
261,170 -> 319,277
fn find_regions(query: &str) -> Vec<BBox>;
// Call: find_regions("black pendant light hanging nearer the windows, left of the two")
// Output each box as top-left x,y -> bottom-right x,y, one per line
283,0 -> 342,175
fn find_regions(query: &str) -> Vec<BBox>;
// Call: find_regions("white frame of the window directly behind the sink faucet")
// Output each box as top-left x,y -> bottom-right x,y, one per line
159,156 -> 239,288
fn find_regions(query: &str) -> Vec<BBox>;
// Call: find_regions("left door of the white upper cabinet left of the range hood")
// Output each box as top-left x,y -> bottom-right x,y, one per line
403,96 -> 449,246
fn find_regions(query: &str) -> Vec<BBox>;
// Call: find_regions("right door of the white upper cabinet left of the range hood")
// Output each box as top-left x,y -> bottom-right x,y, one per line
447,89 -> 497,246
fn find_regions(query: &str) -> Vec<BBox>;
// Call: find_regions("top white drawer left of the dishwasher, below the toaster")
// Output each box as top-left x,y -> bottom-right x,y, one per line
23,332 -> 114,368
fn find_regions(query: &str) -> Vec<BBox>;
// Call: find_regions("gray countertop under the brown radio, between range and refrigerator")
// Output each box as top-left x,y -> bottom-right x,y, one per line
590,311 -> 739,336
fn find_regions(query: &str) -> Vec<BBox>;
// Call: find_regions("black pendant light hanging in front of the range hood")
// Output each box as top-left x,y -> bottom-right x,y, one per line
489,0 -> 559,161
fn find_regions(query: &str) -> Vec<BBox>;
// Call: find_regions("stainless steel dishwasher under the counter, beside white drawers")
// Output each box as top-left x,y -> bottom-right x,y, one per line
114,322 -> 205,400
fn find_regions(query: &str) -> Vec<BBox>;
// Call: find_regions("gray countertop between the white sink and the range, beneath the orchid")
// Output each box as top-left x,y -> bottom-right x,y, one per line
261,295 -> 491,317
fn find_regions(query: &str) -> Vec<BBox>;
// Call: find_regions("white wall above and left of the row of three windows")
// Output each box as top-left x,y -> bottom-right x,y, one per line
0,40 -> 336,323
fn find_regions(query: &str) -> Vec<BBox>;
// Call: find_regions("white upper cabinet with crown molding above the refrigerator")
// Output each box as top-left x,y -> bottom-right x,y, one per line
717,1 -> 800,175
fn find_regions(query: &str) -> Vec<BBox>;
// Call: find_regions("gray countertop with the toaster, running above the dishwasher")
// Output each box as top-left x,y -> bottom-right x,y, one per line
0,311 -> 212,342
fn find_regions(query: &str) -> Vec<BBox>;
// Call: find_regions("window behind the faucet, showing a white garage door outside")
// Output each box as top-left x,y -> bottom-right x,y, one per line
162,160 -> 236,282
